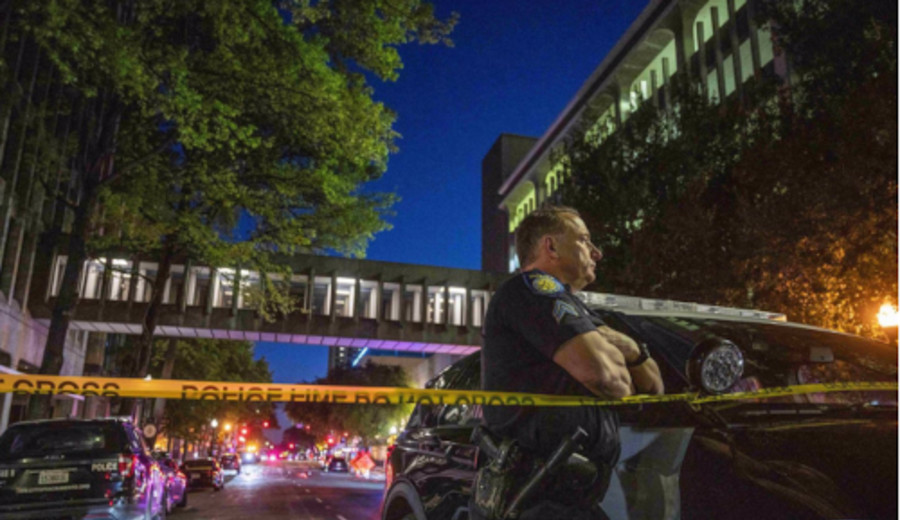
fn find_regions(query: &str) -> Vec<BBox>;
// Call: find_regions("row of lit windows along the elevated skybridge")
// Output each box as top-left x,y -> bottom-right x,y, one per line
51,256 -> 490,327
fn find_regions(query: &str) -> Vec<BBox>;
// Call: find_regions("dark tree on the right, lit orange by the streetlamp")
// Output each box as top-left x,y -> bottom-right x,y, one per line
563,0 -> 897,336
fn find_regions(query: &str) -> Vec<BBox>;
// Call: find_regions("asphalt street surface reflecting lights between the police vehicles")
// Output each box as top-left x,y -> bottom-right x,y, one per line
178,462 -> 384,520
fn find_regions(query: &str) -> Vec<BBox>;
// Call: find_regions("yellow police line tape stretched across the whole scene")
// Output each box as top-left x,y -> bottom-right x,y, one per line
0,374 -> 897,406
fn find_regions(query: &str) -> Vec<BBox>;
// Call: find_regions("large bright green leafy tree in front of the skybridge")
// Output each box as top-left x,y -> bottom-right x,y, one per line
15,0 -> 455,416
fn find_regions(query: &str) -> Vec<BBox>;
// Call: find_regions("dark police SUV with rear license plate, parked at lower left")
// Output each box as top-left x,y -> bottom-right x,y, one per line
0,418 -> 166,519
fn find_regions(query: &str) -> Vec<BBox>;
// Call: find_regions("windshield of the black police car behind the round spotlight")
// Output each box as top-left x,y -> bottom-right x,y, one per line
643,317 -> 897,407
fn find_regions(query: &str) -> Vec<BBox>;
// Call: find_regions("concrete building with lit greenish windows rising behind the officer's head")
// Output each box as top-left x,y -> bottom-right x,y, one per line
482,0 -> 788,272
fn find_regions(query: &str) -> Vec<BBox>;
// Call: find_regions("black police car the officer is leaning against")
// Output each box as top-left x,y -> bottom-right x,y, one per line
381,295 -> 897,520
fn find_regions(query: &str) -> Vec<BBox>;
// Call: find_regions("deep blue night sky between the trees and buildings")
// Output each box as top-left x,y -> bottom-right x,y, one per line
256,0 -> 648,390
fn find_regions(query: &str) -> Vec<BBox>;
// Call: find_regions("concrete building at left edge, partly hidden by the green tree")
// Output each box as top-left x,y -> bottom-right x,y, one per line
0,30 -> 108,432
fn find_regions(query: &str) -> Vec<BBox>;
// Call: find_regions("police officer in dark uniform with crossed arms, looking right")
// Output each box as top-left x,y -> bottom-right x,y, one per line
481,207 -> 663,519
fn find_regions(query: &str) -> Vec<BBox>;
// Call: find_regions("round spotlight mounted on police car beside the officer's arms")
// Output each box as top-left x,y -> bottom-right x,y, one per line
687,338 -> 744,394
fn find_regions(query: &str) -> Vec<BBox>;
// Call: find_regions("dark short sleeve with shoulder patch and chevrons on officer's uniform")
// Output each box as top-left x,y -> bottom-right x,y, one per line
502,274 -> 597,359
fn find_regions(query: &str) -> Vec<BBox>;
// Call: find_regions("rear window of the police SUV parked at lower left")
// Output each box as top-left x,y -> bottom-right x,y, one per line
0,422 -> 125,460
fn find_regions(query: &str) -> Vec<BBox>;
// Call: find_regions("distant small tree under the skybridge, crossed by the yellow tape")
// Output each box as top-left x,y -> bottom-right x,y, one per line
285,361 -> 413,444
